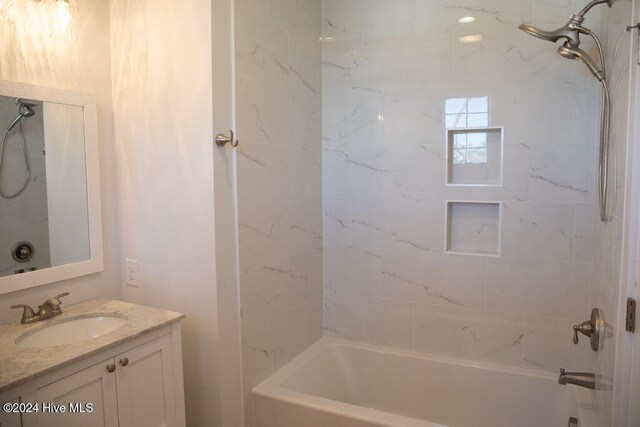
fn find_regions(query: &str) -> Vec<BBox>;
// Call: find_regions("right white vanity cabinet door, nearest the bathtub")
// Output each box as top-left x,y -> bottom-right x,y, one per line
116,335 -> 177,427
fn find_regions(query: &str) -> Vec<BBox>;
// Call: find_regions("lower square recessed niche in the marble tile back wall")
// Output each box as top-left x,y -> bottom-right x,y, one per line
446,201 -> 501,256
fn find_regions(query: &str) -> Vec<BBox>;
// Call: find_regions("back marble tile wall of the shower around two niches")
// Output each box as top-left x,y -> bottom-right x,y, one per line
322,0 -> 608,378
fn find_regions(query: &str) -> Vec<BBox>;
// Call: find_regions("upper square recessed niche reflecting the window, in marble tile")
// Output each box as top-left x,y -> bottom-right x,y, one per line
447,127 -> 503,186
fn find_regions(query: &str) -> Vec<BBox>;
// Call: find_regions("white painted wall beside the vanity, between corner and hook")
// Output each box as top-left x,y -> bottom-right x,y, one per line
110,0 -> 219,426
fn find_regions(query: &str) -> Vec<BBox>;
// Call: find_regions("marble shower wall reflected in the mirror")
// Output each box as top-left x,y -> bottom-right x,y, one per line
0,96 -> 51,276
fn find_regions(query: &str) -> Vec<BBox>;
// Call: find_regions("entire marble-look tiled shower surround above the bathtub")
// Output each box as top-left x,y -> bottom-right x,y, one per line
235,0 -> 631,425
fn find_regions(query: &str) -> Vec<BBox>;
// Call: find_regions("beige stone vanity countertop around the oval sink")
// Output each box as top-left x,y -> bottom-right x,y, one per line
0,298 -> 184,392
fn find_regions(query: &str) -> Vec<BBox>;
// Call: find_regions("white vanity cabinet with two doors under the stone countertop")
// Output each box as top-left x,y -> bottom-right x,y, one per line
0,324 -> 185,427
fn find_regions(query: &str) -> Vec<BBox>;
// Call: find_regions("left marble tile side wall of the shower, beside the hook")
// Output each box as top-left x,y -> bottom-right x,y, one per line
235,0 -> 323,426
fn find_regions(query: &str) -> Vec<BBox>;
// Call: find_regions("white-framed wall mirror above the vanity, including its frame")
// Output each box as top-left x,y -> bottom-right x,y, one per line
0,81 -> 103,294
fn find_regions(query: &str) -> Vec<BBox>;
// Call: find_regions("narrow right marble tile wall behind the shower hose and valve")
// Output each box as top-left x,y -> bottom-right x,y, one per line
587,0 -> 635,425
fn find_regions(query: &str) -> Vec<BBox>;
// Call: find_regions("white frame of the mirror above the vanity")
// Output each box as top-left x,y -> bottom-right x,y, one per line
0,80 -> 104,294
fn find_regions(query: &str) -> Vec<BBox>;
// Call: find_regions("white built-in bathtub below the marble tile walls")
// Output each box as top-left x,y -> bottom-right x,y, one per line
253,337 -> 586,427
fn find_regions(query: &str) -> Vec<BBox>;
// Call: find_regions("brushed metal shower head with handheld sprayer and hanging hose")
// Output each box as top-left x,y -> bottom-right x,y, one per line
519,0 -> 614,222
